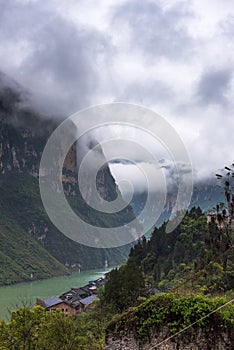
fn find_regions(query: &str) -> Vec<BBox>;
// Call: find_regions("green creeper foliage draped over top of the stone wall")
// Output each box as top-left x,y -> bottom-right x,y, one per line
108,293 -> 234,342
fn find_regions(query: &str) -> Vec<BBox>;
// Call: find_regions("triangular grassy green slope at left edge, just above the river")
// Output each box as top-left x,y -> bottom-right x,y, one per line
0,215 -> 69,285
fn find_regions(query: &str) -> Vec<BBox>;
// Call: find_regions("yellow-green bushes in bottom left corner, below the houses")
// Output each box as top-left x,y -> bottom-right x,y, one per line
0,306 -> 111,350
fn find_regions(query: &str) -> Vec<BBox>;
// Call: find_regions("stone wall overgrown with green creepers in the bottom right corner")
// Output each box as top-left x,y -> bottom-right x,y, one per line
105,294 -> 234,350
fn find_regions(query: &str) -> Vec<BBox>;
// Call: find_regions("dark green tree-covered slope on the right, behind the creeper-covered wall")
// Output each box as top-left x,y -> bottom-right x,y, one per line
98,208 -> 234,312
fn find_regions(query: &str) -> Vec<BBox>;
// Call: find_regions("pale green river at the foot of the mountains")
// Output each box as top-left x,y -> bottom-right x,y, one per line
0,268 -> 110,320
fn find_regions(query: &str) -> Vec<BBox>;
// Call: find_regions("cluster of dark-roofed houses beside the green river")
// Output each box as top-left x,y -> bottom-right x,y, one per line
36,273 -> 109,316
